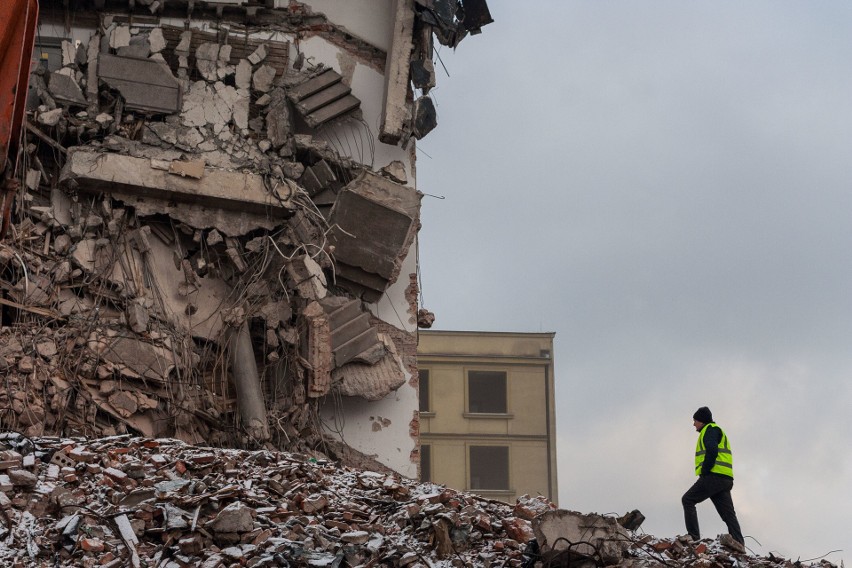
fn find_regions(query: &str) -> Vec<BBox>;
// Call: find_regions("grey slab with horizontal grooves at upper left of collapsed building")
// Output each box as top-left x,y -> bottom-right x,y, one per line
98,54 -> 180,113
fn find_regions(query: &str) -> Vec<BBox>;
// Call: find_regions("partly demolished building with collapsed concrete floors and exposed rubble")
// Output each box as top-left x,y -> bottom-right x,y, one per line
0,0 -> 491,477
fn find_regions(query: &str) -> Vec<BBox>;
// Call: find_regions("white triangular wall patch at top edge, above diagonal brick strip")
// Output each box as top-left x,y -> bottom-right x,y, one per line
282,0 -> 393,51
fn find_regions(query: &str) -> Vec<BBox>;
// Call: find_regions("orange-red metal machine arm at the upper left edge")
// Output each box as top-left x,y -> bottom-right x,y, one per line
0,0 -> 38,239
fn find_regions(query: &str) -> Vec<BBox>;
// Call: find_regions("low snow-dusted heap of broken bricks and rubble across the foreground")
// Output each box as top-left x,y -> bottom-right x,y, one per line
0,433 -> 844,568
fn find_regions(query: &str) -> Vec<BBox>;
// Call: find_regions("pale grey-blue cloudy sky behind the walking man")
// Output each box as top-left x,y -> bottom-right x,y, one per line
418,0 -> 852,563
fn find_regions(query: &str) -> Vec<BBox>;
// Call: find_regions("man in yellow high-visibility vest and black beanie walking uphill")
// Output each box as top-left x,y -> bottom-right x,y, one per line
681,406 -> 745,545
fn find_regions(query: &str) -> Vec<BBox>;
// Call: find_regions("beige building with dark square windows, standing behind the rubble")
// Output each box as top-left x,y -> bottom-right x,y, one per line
417,330 -> 558,503
